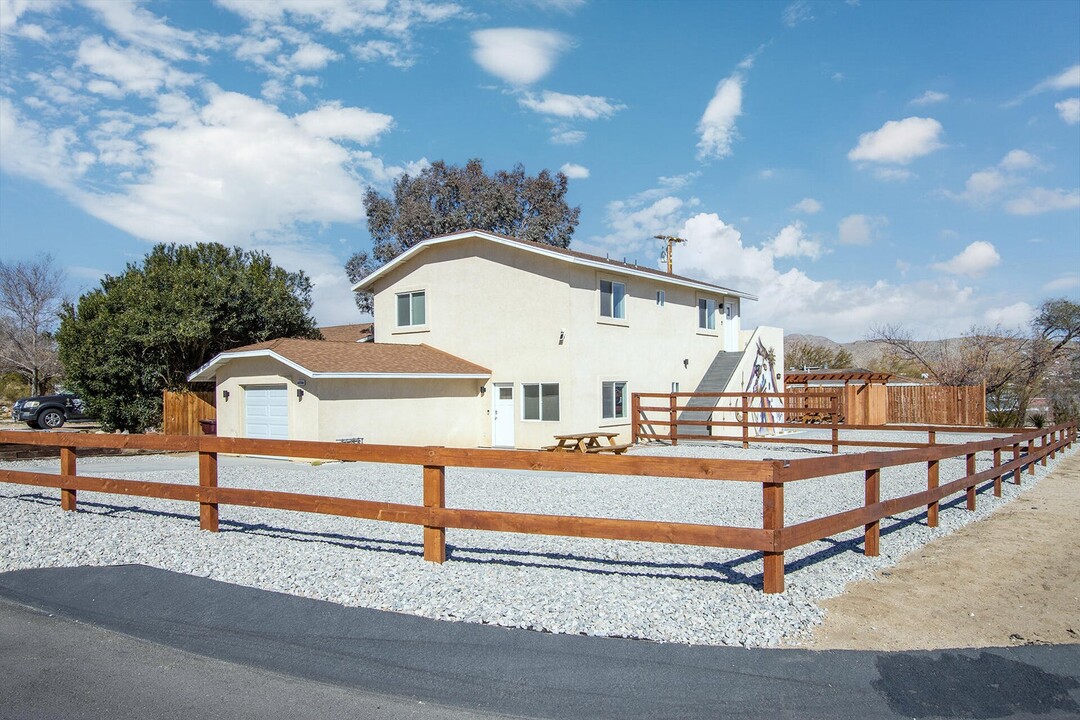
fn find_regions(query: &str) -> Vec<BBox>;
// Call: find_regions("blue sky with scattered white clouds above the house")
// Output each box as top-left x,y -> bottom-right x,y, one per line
0,0 -> 1080,340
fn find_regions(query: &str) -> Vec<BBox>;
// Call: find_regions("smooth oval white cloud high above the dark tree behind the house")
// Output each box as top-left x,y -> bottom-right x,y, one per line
472,27 -> 571,85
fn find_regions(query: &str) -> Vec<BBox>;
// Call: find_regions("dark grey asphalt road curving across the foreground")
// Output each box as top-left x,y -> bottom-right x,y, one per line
0,566 -> 1080,720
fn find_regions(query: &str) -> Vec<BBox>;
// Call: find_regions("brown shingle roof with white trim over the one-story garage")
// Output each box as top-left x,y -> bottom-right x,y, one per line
192,338 -> 491,379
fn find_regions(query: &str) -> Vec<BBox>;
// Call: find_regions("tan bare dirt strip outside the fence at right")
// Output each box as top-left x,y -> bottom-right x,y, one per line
799,447 -> 1080,650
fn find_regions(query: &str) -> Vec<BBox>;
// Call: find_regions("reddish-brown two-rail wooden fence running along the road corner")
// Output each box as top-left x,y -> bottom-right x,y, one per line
0,423 -> 1077,593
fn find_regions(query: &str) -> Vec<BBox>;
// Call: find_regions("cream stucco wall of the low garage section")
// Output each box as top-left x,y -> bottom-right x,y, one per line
217,357 -> 487,447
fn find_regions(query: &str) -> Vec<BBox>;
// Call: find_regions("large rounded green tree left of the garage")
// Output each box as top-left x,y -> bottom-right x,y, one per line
57,243 -> 319,432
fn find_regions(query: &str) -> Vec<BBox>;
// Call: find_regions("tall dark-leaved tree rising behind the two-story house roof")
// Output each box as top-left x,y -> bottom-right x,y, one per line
346,159 -> 581,312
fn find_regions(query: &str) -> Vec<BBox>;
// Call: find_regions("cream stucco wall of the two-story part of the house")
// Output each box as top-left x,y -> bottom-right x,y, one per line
374,240 -> 756,448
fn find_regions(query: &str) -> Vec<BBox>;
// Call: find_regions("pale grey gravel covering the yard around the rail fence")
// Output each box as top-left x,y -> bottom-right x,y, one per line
0,433 -> 1055,647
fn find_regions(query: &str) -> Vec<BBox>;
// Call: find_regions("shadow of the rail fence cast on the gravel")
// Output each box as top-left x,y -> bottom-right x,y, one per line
0,486 -> 988,589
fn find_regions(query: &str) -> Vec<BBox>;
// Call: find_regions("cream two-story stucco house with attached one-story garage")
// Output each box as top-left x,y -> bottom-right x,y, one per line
191,231 -> 783,448
